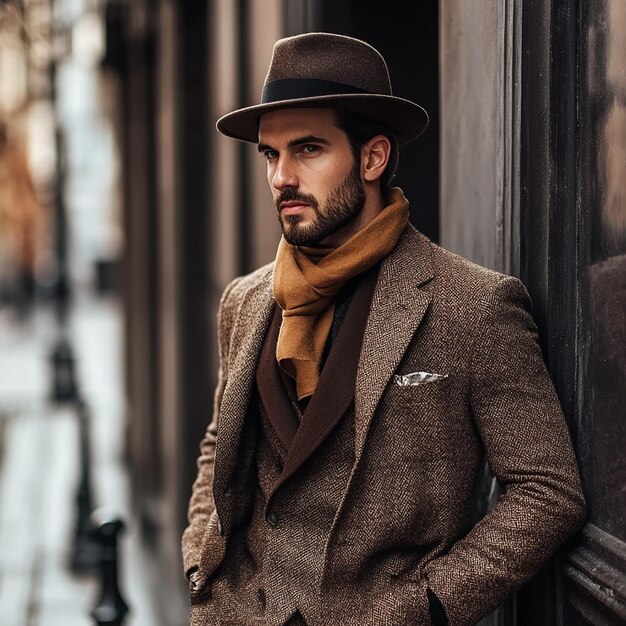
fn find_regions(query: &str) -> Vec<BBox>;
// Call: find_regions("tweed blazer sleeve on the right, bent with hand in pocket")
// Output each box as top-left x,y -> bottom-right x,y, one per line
426,277 -> 585,626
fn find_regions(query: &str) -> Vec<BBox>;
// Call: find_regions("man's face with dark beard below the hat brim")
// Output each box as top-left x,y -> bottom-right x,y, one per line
258,109 -> 365,246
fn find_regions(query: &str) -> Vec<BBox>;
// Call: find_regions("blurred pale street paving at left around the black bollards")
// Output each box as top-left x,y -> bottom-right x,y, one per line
0,296 -> 161,626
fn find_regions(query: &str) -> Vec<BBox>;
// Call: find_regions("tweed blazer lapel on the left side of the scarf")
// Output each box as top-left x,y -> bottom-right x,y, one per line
213,268 -> 274,501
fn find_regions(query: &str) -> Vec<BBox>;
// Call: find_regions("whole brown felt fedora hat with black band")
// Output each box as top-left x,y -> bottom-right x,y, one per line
217,33 -> 428,143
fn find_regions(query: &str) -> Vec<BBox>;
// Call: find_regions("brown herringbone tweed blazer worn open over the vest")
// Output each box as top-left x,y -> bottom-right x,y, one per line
183,226 -> 585,626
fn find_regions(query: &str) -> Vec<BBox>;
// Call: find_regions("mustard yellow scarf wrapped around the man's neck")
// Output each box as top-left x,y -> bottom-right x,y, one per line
274,187 -> 409,400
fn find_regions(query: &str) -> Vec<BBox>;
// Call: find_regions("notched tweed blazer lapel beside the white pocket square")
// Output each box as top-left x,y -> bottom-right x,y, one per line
355,225 -> 434,462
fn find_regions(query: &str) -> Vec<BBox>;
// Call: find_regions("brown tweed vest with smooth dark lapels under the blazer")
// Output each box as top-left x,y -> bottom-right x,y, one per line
212,269 -> 377,626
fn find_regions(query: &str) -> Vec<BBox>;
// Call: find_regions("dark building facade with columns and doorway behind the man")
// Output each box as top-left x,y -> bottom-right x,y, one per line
102,0 -> 626,626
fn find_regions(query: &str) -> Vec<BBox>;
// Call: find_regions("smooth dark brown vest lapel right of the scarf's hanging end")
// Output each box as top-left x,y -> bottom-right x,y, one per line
274,268 -> 377,489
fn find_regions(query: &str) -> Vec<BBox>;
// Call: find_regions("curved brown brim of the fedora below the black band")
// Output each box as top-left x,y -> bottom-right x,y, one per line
216,94 -> 428,144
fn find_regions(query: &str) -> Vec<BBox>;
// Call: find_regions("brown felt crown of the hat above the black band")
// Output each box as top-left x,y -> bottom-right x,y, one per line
265,33 -> 393,96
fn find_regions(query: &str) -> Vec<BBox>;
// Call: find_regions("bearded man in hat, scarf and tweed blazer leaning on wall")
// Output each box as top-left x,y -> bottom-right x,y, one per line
183,33 -> 585,626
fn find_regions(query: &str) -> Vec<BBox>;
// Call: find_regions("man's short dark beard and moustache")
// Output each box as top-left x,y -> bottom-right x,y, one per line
274,159 -> 365,246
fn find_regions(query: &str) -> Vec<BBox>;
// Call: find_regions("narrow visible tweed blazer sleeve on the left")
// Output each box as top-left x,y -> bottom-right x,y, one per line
182,278 -> 240,578
